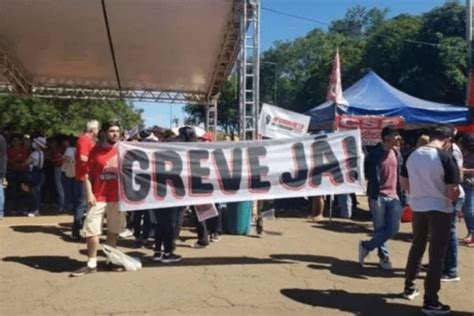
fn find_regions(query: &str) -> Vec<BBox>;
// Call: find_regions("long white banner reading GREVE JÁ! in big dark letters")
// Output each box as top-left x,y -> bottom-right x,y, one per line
118,130 -> 364,211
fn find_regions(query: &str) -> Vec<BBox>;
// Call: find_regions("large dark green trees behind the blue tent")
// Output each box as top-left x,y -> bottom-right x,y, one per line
260,0 -> 467,117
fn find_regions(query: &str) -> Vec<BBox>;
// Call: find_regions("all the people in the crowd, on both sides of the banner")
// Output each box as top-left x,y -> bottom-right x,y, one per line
0,120 -> 474,314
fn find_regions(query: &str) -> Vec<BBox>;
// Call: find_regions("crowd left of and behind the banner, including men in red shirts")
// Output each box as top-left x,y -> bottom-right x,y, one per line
0,120 -> 226,276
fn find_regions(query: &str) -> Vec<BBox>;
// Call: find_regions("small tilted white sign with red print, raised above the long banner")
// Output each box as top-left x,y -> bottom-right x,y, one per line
258,103 -> 311,139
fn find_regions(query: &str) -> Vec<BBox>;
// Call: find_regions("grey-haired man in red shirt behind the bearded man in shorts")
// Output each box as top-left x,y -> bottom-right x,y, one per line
71,120 -> 99,240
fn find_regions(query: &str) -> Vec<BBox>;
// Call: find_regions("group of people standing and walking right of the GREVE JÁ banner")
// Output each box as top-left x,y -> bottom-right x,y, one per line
358,126 -> 474,315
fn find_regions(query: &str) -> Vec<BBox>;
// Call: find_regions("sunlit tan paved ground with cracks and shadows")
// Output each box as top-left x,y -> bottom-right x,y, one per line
0,199 -> 474,316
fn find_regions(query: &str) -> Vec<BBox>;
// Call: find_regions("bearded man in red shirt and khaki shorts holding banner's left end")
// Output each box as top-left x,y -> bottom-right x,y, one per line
71,122 -> 125,276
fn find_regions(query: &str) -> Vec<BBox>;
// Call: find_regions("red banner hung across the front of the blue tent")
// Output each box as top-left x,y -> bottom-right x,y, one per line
336,114 -> 405,145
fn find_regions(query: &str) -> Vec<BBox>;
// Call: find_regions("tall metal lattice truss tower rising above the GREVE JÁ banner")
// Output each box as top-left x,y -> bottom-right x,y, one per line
239,0 -> 260,140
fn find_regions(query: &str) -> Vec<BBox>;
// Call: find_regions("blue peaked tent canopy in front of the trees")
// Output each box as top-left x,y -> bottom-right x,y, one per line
306,71 -> 469,128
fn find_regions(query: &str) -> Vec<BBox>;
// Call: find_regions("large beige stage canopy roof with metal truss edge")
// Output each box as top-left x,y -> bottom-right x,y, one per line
0,0 -> 242,103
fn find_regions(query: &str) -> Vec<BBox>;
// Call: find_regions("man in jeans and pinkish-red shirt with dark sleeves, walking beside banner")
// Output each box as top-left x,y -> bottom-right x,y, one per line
359,125 -> 402,270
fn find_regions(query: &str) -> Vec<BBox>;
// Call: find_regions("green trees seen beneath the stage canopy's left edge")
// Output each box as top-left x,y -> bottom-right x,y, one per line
0,96 -> 141,136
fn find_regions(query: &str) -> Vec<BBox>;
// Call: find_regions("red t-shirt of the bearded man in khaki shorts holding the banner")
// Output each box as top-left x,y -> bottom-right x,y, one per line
88,145 -> 118,202
